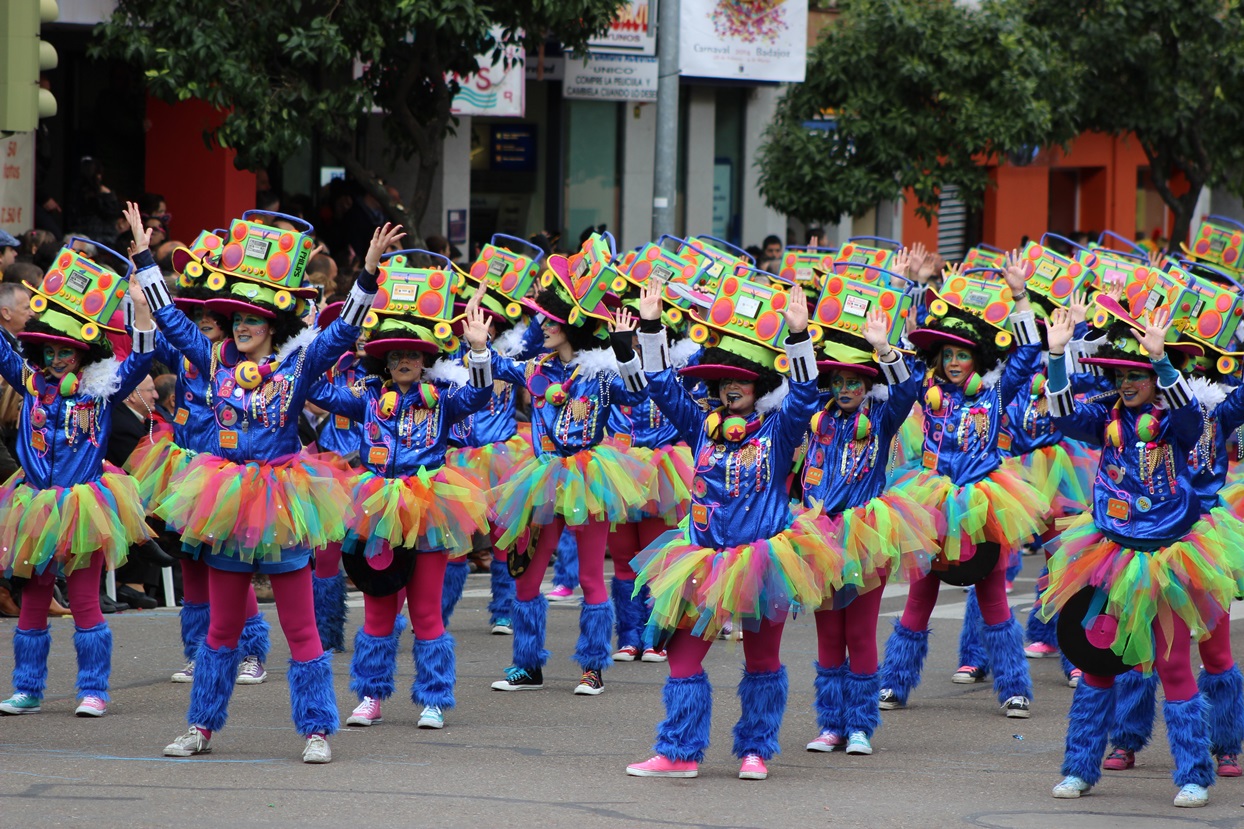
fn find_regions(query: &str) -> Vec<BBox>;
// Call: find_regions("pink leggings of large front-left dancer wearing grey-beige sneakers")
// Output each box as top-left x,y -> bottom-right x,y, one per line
208,565 -> 323,662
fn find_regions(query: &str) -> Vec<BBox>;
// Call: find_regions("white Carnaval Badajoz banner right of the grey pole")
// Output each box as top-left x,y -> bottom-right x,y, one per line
678,0 -> 807,83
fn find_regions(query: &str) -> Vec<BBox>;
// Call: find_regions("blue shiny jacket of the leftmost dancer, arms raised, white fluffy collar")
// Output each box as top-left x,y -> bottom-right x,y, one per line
0,331 -> 156,489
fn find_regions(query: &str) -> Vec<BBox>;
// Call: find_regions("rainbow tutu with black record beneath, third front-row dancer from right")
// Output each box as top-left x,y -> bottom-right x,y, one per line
894,467 -> 1050,564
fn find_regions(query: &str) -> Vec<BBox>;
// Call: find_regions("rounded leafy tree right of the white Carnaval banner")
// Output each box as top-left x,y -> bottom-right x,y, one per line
759,0 -> 1076,222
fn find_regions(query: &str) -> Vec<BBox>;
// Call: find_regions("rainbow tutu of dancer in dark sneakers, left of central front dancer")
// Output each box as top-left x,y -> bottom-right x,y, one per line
495,444 -> 654,548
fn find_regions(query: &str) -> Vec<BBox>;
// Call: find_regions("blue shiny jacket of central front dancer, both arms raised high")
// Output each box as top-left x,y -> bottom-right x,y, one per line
639,334 -> 819,549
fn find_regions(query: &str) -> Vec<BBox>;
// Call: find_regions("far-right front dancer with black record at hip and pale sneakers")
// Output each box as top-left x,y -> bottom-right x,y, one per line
1041,302 -> 1238,807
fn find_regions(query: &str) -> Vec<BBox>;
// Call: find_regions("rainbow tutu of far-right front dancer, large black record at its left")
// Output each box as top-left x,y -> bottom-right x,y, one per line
1040,513 -> 1244,670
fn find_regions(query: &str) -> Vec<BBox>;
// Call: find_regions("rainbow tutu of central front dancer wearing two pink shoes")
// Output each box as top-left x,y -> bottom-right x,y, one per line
631,507 -> 863,640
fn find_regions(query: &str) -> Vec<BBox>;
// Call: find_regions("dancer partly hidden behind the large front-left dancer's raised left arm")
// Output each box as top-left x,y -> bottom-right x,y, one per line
128,230 -> 269,685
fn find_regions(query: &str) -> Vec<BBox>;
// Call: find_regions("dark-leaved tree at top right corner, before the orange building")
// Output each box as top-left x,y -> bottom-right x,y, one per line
1006,0 -> 1244,248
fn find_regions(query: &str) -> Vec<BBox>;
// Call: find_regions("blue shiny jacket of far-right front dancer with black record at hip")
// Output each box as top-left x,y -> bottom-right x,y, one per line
1049,363 -> 1204,542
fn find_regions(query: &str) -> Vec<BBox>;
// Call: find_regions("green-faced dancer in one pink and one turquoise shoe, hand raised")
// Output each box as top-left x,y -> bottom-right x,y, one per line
802,310 -> 939,754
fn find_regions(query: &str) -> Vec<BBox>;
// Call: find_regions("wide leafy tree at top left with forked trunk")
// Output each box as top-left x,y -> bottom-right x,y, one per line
95,0 -> 623,243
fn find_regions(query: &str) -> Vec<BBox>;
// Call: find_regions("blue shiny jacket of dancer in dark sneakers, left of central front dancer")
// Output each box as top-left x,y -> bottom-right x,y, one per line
493,349 -> 647,457
